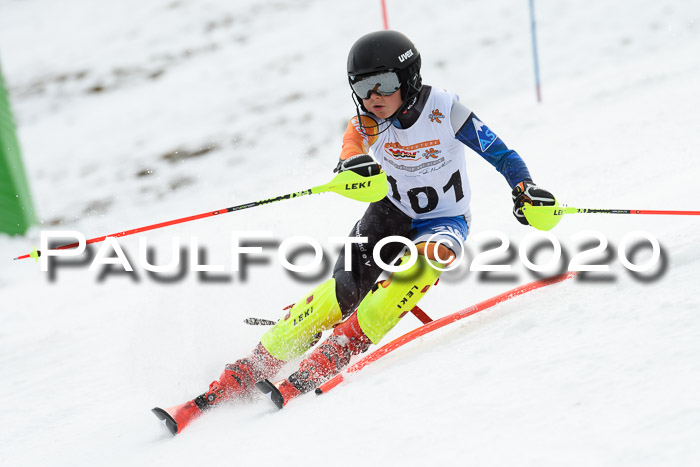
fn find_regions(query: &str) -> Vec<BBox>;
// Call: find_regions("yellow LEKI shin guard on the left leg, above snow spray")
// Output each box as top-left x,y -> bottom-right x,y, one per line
260,279 -> 342,361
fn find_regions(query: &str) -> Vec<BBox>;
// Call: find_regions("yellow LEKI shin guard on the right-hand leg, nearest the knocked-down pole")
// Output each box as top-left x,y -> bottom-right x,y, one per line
357,255 -> 443,344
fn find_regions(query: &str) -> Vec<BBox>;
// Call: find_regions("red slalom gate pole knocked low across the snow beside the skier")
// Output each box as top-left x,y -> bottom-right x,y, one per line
316,271 -> 577,394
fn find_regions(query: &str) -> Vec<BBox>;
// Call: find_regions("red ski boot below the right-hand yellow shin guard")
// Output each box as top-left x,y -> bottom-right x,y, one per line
255,312 -> 372,409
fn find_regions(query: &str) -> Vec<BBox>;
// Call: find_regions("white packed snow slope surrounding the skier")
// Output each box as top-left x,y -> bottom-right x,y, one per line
0,0 -> 700,466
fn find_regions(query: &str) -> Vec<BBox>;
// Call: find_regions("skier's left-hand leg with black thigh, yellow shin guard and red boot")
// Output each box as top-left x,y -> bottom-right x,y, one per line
154,199 -> 411,433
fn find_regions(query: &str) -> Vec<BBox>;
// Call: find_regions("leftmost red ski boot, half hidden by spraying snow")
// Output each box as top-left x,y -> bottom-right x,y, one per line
151,344 -> 284,435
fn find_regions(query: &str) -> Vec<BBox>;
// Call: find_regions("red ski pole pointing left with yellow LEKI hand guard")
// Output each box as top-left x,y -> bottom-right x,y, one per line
14,170 -> 389,261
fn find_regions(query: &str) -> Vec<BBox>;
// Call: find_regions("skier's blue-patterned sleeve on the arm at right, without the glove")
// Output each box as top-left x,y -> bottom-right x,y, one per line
450,101 -> 532,188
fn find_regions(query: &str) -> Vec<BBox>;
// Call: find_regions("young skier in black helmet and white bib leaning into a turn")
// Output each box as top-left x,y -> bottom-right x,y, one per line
153,31 -> 555,434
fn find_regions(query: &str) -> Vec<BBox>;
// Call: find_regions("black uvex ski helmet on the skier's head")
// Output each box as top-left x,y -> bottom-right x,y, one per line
348,31 -> 422,103
